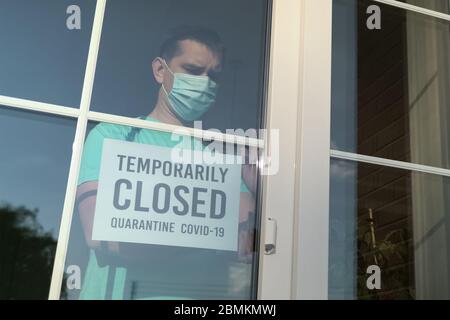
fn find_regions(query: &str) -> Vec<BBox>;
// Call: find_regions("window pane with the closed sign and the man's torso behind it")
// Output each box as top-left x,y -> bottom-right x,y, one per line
62,117 -> 258,299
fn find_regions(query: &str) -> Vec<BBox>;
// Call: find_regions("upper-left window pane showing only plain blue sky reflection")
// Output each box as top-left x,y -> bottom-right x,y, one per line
0,0 -> 95,107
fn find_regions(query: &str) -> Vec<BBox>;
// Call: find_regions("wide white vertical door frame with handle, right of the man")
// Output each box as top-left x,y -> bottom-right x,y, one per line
258,0 -> 332,299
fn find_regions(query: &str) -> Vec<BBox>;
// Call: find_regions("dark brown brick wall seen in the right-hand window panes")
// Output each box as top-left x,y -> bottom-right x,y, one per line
357,1 -> 414,299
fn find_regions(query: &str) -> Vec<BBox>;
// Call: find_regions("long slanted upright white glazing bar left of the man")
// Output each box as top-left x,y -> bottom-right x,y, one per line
49,0 -> 106,300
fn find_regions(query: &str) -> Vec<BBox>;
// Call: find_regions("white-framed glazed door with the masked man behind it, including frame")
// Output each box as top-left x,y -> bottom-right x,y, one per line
0,0 -> 332,299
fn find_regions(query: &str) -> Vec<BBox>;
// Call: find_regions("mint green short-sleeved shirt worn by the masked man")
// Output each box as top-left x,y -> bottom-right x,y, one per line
78,117 -> 249,300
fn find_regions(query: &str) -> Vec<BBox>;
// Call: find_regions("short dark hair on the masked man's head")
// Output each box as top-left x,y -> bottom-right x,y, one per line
159,26 -> 225,62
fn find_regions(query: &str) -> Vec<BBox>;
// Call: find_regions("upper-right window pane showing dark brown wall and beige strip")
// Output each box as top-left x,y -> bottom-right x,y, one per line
331,0 -> 450,168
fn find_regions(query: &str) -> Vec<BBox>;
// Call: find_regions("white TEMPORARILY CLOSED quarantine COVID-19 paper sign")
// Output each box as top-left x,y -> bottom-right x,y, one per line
92,139 -> 241,251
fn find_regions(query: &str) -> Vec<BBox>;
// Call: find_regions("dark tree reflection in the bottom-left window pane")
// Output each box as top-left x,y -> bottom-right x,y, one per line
0,205 -> 64,299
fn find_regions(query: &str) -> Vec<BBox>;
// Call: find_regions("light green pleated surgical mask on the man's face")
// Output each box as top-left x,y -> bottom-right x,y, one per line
162,61 -> 217,122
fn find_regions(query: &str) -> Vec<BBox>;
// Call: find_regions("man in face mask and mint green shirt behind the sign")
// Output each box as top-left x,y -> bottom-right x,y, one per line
77,27 -> 255,299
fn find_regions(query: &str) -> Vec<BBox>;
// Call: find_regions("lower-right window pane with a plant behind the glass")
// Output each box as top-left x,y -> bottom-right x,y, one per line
329,160 -> 450,300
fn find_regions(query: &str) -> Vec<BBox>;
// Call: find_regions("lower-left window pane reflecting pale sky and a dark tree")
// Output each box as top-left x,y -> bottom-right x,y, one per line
0,106 -> 76,299
